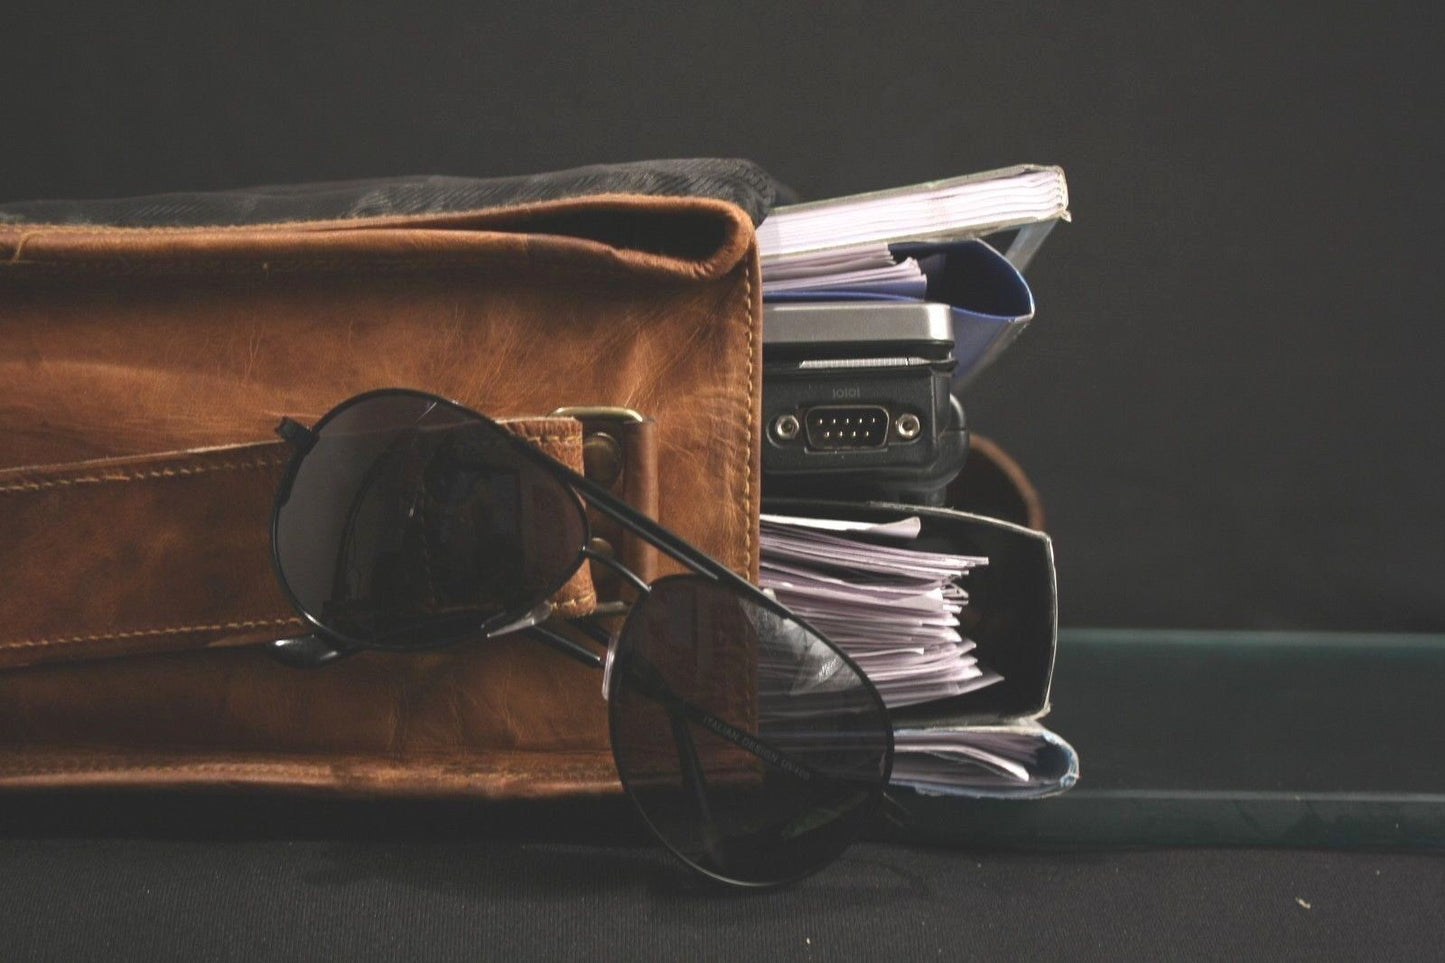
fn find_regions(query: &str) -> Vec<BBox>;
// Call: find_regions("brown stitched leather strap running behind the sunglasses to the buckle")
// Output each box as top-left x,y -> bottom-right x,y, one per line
0,418 -> 656,668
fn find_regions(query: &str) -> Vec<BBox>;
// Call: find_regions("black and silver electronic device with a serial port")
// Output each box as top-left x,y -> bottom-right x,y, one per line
763,301 -> 968,506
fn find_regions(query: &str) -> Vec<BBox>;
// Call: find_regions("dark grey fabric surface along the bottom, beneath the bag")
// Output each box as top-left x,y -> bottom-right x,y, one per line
0,839 -> 1445,963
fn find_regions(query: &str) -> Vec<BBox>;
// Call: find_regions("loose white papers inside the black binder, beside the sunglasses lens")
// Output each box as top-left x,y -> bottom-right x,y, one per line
760,515 -> 1001,709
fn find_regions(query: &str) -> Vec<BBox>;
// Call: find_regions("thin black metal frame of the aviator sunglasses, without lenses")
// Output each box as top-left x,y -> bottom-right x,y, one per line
262,388 -> 893,888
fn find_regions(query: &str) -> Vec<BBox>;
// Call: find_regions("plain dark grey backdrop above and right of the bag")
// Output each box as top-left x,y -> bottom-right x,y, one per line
0,0 -> 1445,630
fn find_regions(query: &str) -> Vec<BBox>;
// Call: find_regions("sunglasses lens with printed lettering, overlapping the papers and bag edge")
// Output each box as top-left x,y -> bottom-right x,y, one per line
610,577 -> 893,883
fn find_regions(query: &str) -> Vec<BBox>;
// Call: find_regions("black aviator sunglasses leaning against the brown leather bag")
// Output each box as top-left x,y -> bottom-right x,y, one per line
262,389 -> 893,886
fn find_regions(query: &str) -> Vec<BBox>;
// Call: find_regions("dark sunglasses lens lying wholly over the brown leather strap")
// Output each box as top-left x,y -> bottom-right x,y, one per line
275,393 -> 585,648
